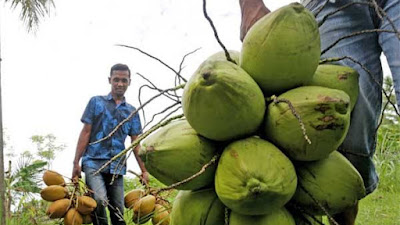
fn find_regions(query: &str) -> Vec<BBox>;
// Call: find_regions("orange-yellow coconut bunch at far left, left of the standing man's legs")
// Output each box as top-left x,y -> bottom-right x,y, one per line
40,170 -> 97,225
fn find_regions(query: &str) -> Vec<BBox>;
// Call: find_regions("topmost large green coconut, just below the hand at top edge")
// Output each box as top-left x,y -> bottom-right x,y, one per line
240,3 -> 321,95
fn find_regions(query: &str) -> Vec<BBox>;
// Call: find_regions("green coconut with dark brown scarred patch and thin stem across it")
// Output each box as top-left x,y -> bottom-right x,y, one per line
265,86 -> 351,161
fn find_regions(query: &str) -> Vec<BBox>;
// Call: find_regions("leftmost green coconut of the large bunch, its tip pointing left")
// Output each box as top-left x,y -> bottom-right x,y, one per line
139,120 -> 217,190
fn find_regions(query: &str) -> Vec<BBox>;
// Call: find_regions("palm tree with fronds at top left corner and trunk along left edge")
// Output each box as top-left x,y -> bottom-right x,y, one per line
0,0 -> 54,225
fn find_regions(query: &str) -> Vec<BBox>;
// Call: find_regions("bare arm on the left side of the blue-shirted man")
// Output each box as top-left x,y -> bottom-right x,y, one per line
72,123 -> 92,179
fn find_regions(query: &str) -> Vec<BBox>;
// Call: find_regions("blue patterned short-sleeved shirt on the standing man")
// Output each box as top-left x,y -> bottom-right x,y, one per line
81,94 -> 142,175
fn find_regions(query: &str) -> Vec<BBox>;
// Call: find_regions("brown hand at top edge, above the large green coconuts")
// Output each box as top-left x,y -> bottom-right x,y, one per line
240,0 -> 270,41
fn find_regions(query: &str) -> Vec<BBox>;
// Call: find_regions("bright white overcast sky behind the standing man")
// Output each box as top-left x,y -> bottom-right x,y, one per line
0,0 -> 390,177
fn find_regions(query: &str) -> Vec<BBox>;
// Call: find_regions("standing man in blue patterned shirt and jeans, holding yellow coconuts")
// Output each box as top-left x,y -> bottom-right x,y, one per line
72,64 -> 148,225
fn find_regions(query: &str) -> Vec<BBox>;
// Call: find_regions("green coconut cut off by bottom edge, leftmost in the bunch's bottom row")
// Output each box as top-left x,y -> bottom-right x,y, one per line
170,189 -> 225,225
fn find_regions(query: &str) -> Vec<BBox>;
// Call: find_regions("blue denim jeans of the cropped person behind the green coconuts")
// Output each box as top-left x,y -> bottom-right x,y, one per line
306,0 -> 400,193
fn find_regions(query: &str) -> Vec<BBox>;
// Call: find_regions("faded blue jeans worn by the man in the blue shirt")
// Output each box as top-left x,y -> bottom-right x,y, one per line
83,167 -> 125,225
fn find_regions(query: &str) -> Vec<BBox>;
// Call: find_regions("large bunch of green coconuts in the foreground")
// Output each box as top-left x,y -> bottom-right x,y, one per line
140,3 -> 365,225
